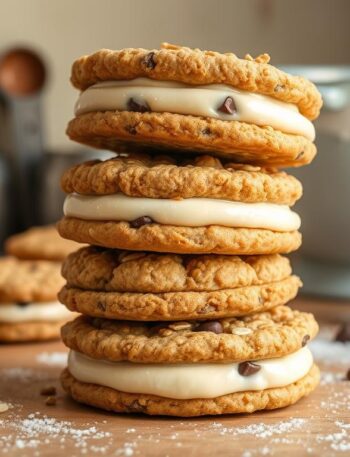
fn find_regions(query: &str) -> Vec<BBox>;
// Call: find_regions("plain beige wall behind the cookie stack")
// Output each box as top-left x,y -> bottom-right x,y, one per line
0,0 -> 350,149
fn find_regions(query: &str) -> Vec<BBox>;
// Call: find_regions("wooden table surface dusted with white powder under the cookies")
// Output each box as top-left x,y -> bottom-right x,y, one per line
0,298 -> 350,457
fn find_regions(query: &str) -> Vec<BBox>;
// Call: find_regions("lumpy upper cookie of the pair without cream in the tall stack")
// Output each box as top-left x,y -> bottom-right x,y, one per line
62,246 -> 292,293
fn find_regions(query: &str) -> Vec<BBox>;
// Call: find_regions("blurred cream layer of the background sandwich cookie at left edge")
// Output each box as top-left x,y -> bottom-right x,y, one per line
0,302 -> 72,324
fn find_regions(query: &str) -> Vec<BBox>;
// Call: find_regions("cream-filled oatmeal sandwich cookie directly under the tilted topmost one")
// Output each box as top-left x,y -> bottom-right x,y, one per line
58,154 -> 302,255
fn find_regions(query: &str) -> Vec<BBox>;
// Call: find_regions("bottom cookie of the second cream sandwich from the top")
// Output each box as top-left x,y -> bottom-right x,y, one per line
57,217 -> 301,255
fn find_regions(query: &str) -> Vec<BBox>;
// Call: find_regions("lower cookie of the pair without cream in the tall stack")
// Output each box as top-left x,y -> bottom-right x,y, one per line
58,276 -> 301,321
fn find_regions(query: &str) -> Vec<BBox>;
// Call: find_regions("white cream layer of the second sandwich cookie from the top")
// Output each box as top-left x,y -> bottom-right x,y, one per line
63,194 -> 300,232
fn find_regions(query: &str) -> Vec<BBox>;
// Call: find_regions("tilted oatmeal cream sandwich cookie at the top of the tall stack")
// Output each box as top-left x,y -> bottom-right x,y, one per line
67,43 -> 322,166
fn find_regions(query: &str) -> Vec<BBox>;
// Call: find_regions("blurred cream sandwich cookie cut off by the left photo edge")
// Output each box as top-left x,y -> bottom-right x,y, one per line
0,257 -> 73,342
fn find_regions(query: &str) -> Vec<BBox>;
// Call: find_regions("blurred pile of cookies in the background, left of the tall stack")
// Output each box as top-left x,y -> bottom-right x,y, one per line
0,226 -> 79,343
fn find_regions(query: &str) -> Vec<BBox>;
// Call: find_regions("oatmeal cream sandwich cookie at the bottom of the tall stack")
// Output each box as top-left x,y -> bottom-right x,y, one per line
61,306 -> 319,416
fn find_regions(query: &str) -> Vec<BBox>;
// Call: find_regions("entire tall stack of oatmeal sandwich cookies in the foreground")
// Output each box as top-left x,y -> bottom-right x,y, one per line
58,45 -> 322,416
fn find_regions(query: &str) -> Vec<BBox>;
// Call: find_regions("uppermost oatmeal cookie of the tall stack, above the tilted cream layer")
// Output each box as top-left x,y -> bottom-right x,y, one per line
71,43 -> 322,119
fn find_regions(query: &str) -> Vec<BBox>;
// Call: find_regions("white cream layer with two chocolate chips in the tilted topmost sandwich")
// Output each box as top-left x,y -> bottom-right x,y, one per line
75,78 -> 315,141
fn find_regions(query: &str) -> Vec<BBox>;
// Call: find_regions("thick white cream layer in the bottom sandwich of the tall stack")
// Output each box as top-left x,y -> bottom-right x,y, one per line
68,347 -> 313,400
